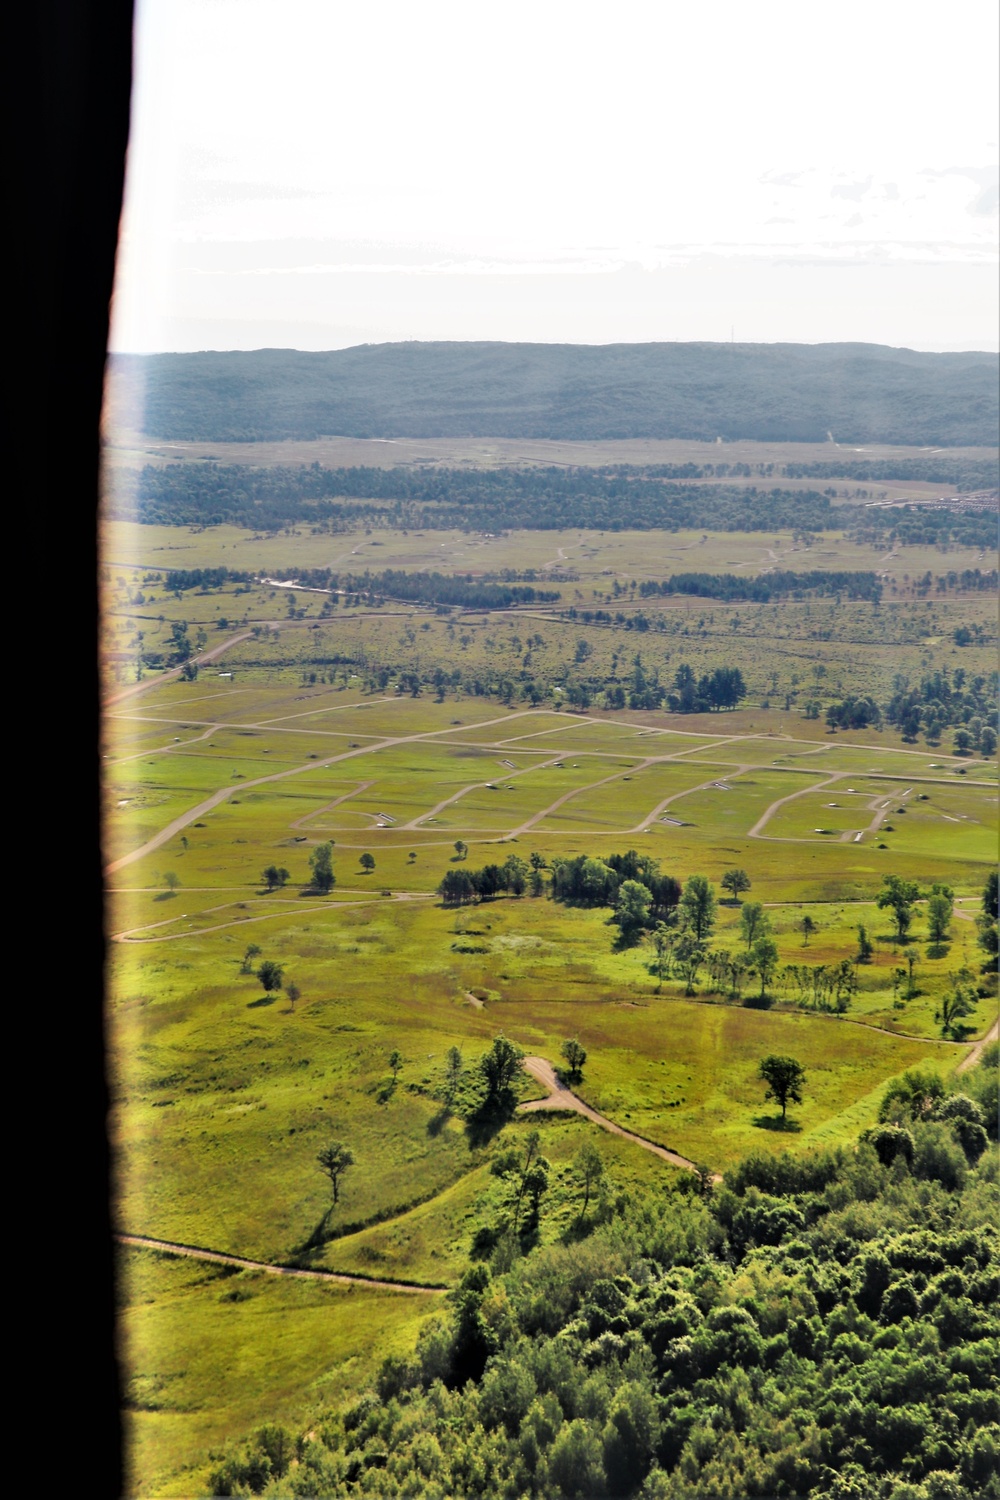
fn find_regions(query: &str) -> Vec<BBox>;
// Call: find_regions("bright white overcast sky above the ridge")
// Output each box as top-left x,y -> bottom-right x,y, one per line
111,0 -> 1000,353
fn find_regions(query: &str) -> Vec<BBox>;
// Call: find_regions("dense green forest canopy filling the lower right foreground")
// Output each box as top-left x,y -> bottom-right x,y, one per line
211,1046 -> 1000,1500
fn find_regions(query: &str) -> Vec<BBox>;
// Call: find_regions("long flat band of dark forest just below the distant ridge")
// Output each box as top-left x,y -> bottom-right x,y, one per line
111,464 -> 997,548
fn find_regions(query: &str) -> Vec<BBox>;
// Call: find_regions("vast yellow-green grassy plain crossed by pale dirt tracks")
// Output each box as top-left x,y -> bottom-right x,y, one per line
102,501 -> 997,1496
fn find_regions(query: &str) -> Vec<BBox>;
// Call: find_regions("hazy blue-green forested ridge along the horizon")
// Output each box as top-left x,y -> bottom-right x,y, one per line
109,342 -> 999,447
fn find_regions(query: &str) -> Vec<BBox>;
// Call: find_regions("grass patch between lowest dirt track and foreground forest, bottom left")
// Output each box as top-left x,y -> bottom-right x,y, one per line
118,1248 -> 439,1500
